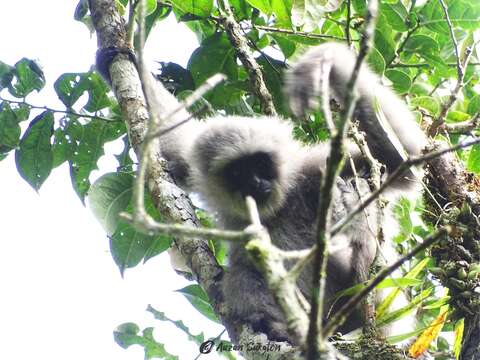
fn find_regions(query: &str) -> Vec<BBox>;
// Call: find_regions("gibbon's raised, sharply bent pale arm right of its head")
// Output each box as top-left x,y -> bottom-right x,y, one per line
286,43 -> 426,187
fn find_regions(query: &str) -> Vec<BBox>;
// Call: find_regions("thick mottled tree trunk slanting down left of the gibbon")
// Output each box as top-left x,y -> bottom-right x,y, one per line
90,0 -> 226,334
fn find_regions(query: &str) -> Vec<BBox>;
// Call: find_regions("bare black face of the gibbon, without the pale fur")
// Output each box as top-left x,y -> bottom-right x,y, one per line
223,152 -> 278,205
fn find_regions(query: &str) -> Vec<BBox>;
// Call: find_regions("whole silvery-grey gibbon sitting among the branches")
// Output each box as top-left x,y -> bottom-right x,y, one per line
96,43 -> 425,340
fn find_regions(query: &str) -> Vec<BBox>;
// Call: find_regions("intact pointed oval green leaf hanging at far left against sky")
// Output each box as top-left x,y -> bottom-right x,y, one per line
15,111 -> 54,190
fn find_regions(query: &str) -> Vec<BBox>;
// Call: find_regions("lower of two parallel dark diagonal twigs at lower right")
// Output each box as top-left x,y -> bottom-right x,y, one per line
322,226 -> 451,338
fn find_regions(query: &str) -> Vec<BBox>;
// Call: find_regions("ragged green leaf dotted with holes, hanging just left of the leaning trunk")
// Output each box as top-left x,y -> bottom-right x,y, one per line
66,119 -> 125,202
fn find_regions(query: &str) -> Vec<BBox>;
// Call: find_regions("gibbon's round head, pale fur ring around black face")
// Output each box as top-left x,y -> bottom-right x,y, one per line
189,118 -> 303,220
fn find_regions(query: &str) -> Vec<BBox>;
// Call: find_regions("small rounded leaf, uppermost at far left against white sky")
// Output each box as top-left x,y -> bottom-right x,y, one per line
8,58 -> 45,98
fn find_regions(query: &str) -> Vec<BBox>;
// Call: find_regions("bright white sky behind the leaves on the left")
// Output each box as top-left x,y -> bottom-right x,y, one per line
0,0 -> 227,360
